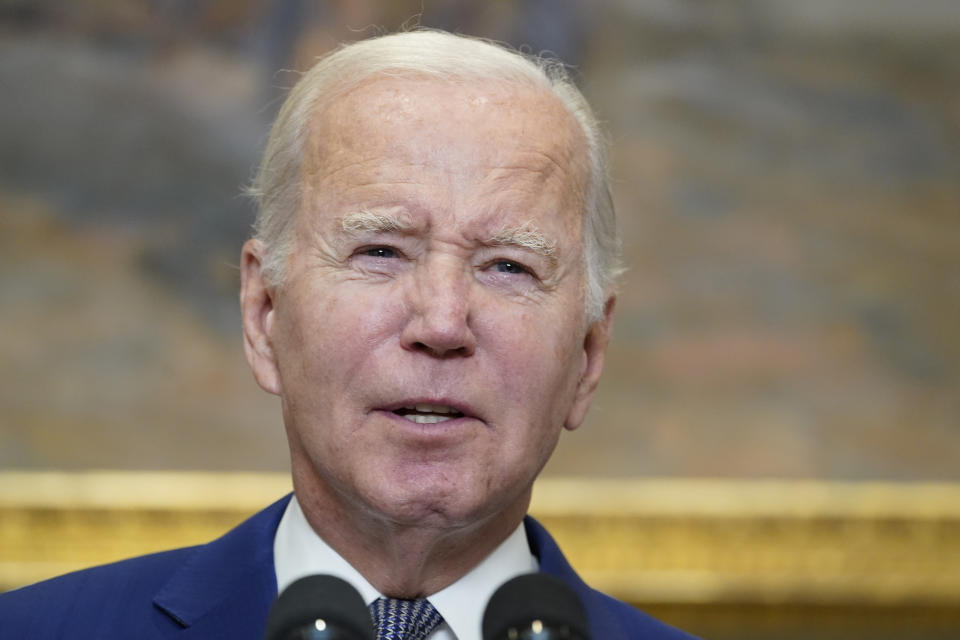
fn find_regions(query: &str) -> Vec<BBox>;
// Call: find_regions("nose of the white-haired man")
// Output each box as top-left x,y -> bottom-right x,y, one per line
400,260 -> 477,358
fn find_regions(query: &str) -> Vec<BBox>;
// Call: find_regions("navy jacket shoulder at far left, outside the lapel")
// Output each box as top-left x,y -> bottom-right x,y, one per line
0,547 -> 197,640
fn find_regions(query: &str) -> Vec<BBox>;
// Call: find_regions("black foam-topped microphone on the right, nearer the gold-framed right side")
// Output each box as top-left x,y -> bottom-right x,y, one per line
482,573 -> 590,640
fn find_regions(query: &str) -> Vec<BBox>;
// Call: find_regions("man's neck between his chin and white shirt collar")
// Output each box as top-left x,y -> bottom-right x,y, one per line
294,474 -> 530,599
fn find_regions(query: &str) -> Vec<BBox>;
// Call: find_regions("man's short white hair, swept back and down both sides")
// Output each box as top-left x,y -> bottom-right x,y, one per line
248,30 -> 620,321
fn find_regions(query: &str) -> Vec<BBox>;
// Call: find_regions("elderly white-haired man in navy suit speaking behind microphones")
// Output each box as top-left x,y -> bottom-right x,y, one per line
0,32 -> 688,640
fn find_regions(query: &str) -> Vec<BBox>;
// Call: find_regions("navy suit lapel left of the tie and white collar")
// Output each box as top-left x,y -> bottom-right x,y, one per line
153,495 -> 290,640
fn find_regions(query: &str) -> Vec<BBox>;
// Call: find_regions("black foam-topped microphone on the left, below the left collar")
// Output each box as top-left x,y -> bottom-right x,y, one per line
264,575 -> 374,640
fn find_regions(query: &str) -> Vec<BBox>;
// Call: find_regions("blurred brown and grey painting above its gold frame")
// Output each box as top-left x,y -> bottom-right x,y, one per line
0,0 -> 960,638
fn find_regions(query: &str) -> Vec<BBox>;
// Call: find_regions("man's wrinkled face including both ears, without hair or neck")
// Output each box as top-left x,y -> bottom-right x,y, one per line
243,78 -> 608,527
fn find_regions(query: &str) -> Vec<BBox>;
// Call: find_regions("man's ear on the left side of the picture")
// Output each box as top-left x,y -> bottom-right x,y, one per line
240,240 -> 280,395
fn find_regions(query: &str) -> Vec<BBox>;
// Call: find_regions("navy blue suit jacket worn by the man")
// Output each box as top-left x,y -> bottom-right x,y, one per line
0,497 -> 691,640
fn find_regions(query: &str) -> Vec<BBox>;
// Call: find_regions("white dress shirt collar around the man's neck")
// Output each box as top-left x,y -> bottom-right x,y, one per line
273,496 -> 539,640
